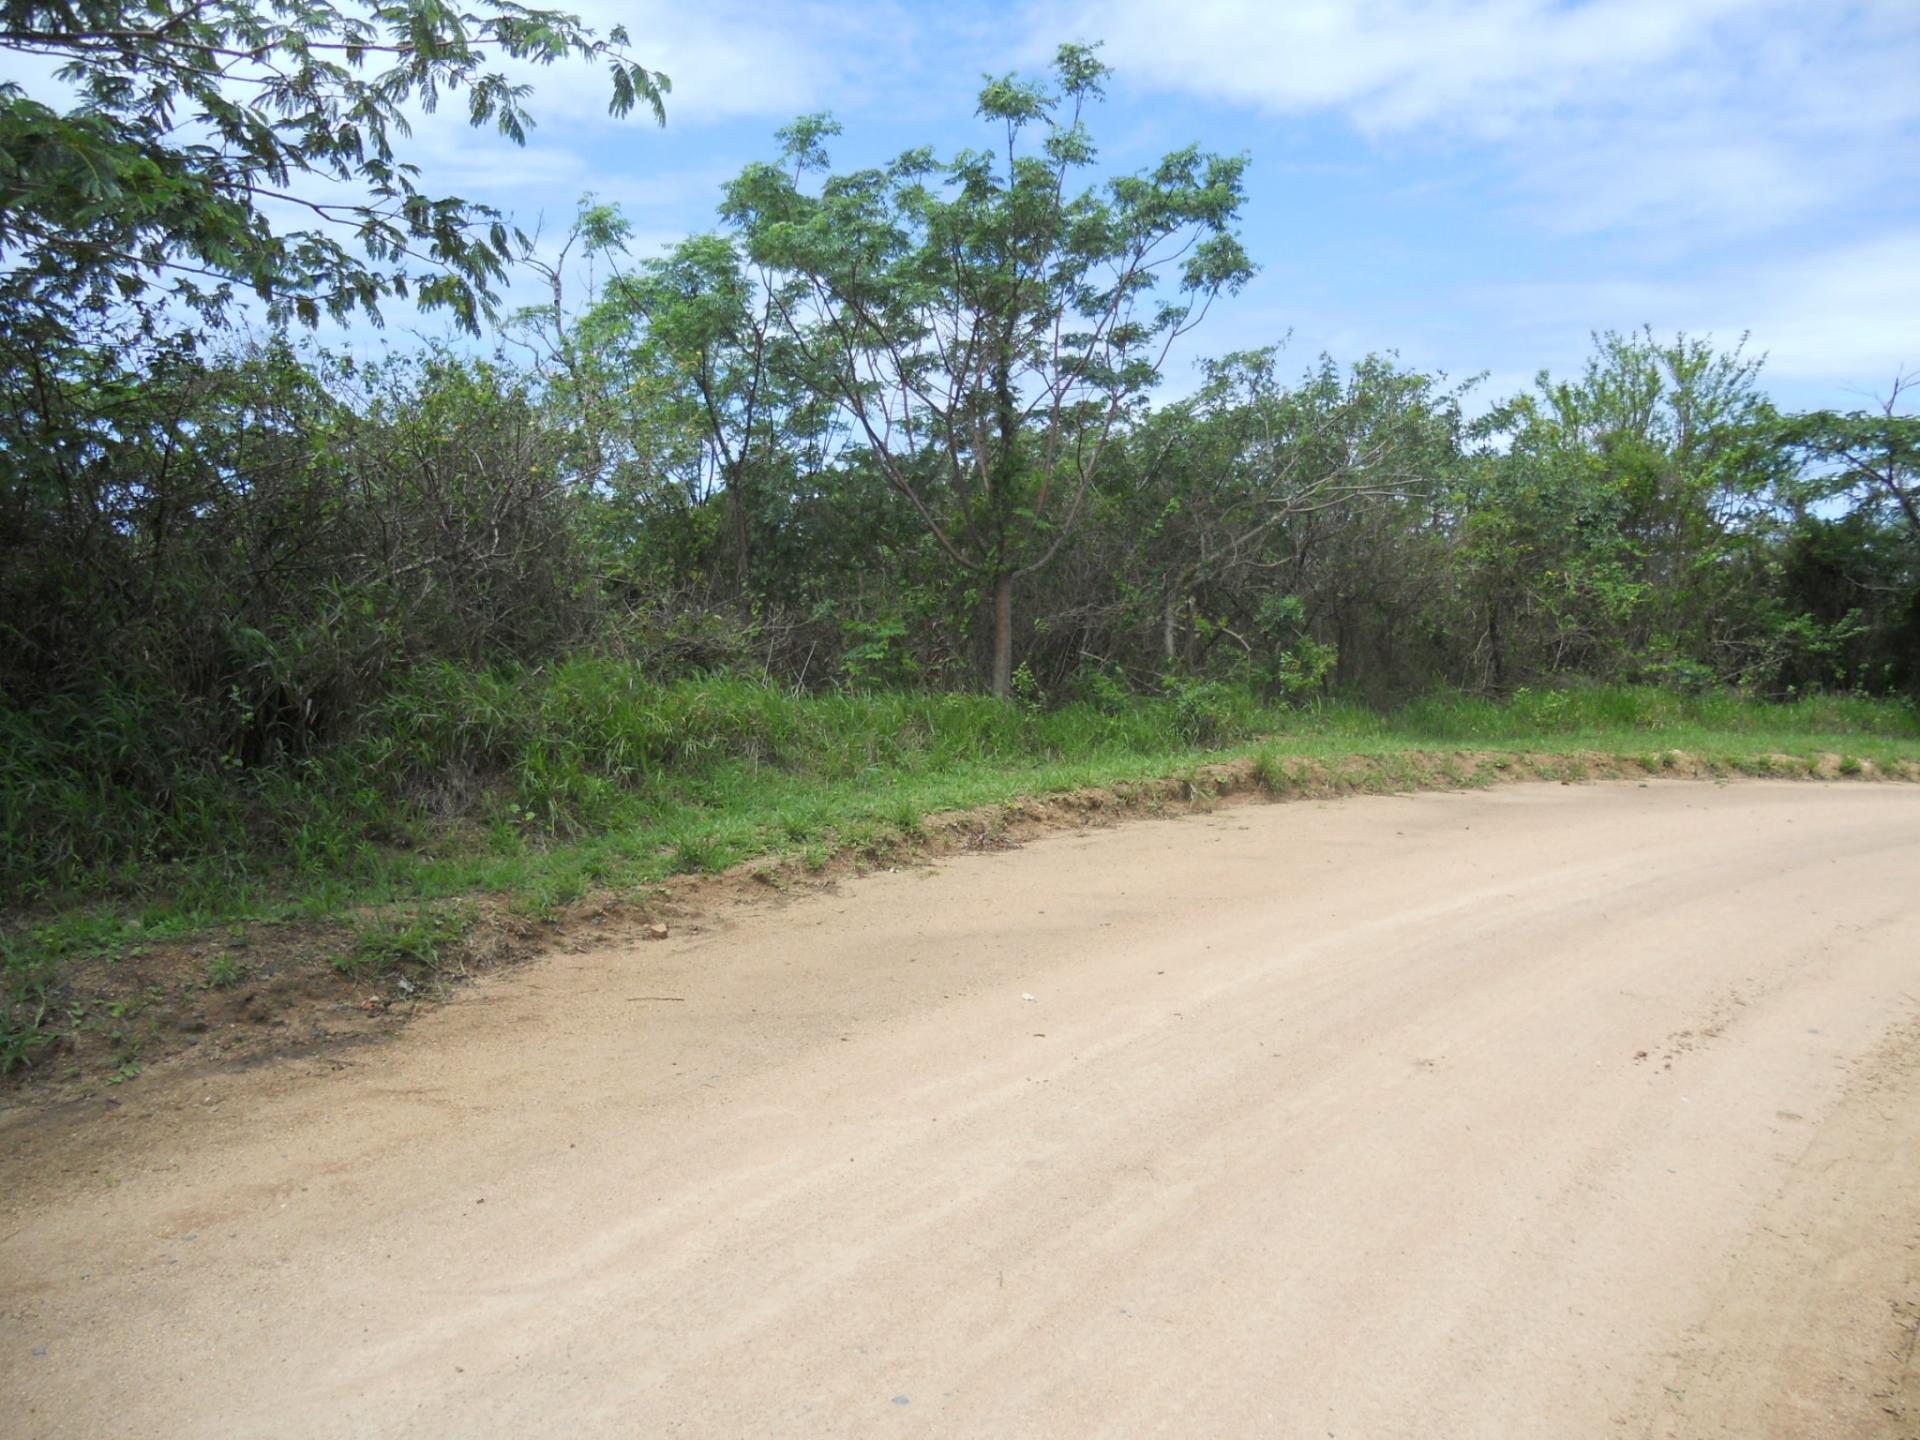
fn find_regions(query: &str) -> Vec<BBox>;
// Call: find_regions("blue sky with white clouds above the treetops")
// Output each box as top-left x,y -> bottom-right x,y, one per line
67,0 -> 1920,416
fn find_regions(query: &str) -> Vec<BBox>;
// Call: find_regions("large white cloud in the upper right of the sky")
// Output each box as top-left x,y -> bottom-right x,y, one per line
1033,0 -> 1920,232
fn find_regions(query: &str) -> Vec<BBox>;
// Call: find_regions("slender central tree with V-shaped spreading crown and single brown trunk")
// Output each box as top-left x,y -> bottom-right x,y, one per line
722,44 -> 1252,697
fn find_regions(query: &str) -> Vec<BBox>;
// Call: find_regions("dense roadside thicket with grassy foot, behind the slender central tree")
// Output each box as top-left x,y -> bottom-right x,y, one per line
0,311 -> 1920,902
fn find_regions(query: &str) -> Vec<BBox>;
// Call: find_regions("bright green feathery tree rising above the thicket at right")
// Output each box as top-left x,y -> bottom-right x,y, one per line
1463,330 -> 1788,689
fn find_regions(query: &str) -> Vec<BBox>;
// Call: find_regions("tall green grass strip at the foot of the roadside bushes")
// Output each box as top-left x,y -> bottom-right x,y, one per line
0,659 -> 1920,908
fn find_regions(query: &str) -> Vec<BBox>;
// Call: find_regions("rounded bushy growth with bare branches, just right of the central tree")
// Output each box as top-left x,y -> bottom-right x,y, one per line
1081,346 -> 1469,697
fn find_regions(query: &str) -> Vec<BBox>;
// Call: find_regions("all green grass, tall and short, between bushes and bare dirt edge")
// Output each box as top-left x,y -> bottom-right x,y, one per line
0,672 -> 1920,1071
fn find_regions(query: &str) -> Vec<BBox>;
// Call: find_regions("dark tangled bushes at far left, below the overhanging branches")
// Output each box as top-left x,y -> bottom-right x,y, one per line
0,349 -> 651,895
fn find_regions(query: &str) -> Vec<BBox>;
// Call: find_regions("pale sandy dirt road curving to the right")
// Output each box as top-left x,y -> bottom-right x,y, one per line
0,783 -> 1920,1440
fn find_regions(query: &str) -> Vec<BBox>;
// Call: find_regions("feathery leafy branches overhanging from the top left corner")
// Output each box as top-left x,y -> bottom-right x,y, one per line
0,0 -> 668,332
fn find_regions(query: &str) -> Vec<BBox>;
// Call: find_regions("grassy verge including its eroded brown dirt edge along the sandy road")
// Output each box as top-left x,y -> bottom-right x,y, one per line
0,683 -> 1920,1083
